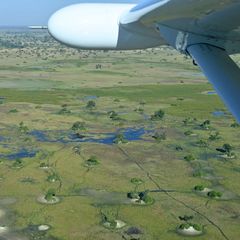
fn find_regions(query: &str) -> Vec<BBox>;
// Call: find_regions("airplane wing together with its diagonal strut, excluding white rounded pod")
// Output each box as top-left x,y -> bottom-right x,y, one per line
120,0 -> 240,122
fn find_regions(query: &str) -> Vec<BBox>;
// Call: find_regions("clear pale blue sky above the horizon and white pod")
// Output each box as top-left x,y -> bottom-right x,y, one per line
0,0 -> 136,26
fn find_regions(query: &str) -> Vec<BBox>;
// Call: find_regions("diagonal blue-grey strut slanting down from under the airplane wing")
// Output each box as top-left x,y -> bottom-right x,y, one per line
187,44 -> 240,122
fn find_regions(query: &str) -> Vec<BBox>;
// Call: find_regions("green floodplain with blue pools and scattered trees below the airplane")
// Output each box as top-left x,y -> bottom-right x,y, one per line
0,29 -> 240,240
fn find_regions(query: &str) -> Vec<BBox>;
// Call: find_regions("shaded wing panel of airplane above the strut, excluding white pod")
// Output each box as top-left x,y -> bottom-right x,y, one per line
120,0 -> 240,50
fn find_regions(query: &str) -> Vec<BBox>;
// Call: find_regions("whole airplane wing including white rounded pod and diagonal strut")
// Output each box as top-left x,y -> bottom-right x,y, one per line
49,0 -> 240,122
